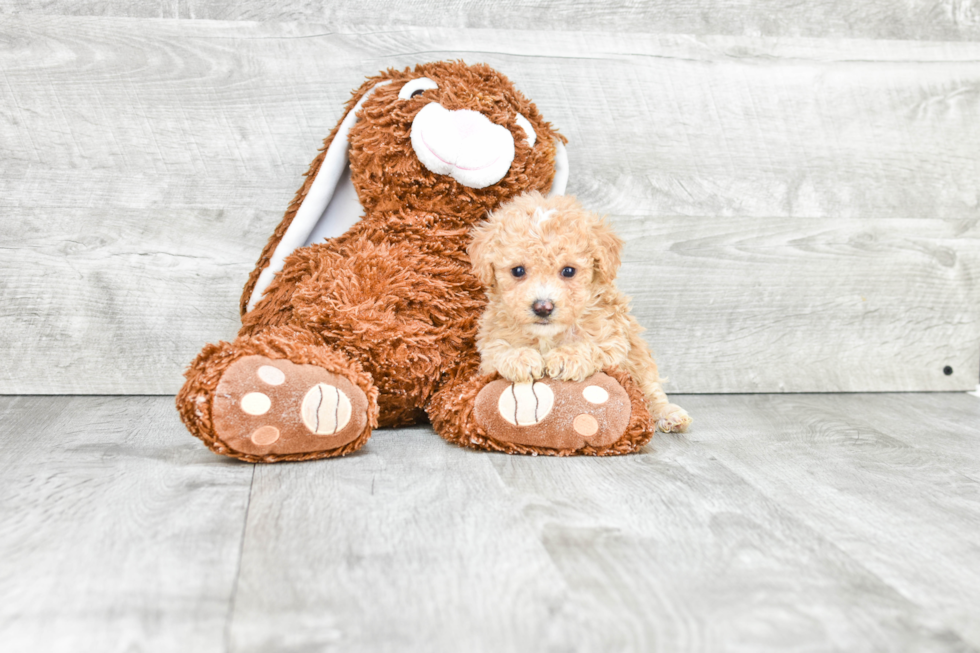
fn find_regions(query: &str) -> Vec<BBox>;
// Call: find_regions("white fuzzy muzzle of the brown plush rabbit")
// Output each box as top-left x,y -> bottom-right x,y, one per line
412,102 -> 514,188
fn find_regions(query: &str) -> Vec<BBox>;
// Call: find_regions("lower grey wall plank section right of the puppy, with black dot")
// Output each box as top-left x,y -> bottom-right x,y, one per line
613,216 -> 980,393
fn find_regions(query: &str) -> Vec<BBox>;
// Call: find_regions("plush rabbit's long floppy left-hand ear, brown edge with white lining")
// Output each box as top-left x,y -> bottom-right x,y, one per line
241,80 -> 391,315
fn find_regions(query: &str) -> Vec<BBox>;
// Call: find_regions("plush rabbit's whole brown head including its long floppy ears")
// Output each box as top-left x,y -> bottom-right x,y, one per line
241,61 -> 568,314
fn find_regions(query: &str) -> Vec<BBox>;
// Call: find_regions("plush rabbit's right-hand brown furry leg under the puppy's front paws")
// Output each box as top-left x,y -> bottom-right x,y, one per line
427,366 -> 656,456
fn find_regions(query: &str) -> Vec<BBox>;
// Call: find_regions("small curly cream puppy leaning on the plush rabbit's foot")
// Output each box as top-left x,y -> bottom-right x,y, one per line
468,192 -> 691,433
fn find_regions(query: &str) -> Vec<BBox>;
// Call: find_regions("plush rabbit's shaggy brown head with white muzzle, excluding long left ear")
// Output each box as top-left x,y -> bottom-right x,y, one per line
348,62 -> 564,219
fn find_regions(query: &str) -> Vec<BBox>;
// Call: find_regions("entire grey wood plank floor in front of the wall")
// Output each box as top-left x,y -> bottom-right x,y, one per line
0,394 -> 980,653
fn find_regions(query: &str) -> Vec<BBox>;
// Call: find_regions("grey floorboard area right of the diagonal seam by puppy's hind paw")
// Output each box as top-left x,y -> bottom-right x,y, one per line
687,395 -> 980,648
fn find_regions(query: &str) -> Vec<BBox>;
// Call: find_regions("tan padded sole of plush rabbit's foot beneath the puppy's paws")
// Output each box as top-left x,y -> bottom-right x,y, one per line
473,372 -> 632,454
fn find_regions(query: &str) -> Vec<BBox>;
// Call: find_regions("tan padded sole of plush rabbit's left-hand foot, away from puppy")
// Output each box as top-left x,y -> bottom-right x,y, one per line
211,356 -> 368,459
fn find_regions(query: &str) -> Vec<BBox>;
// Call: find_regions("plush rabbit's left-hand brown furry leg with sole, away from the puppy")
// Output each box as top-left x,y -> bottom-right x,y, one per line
177,327 -> 378,462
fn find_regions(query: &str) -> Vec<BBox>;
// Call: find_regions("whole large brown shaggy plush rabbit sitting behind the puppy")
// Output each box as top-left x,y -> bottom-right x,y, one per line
177,62 -> 652,462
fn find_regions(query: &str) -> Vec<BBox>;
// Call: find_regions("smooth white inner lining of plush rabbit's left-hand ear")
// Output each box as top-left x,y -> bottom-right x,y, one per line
245,80 -> 391,311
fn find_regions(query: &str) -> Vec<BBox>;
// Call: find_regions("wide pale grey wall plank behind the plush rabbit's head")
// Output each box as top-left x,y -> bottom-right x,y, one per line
0,16 -> 980,219
